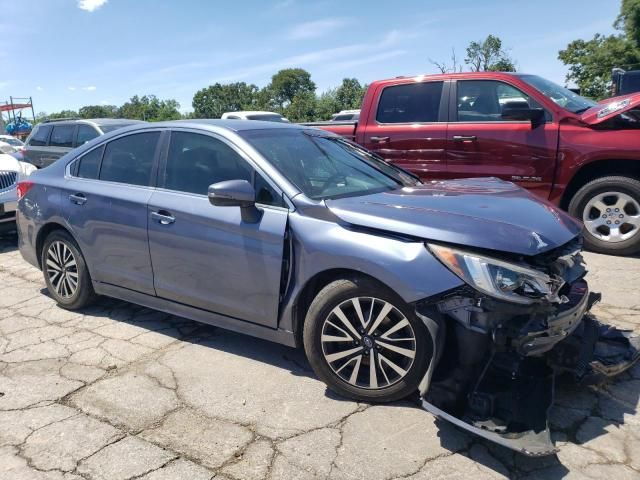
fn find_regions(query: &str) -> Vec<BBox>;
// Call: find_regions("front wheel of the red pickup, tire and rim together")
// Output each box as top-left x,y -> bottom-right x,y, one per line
569,176 -> 640,255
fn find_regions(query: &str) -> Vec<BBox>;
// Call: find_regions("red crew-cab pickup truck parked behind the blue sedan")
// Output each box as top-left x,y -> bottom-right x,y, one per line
313,72 -> 640,255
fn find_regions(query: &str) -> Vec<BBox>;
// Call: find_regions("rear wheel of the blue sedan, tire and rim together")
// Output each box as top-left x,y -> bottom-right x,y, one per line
41,230 -> 96,310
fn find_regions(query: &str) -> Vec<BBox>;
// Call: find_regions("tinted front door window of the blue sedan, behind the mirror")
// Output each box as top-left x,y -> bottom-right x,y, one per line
164,132 -> 253,195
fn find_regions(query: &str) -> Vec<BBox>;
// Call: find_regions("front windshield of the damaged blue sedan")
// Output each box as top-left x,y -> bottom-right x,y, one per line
240,129 -> 416,200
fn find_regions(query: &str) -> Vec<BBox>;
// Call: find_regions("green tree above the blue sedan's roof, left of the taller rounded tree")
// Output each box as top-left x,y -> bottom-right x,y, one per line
192,82 -> 258,118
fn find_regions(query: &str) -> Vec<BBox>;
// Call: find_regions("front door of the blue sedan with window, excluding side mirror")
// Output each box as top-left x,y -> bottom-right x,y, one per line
148,130 -> 288,327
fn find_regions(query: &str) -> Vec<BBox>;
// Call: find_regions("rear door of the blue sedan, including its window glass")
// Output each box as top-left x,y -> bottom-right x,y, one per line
62,130 -> 161,295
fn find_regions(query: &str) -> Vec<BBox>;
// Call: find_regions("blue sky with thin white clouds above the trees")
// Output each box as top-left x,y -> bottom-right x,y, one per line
0,0 -> 620,113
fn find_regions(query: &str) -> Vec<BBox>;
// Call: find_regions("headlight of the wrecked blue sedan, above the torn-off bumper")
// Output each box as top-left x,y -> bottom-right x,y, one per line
427,244 -> 556,304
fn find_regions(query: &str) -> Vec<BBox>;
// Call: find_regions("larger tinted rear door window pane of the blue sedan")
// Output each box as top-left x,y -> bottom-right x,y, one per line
100,132 -> 160,185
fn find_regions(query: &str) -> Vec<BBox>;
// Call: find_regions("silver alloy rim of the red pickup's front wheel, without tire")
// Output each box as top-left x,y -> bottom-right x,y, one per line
582,192 -> 640,243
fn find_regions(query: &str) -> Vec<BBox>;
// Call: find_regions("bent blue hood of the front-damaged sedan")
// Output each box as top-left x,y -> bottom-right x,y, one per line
326,178 -> 582,255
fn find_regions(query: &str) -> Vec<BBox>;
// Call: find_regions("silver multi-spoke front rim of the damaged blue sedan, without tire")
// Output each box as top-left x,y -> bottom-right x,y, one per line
320,297 -> 416,390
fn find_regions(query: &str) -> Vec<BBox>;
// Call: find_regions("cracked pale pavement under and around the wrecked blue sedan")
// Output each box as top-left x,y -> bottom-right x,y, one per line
0,230 -> 640,480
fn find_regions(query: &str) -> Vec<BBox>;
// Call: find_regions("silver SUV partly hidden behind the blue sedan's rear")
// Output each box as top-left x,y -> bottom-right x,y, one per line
24,118 -> 144,168
